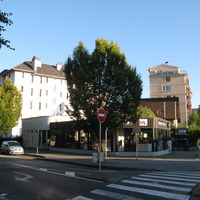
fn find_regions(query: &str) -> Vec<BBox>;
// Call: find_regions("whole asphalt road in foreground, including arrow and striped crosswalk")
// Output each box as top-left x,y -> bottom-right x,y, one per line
0,155 -> 200,200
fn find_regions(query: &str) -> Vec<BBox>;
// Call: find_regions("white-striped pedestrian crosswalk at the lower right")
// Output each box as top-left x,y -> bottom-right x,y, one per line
72,171 -> 200,200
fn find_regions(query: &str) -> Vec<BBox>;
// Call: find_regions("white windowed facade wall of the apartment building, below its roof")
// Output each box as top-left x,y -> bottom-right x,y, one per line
10,71 -> 69,119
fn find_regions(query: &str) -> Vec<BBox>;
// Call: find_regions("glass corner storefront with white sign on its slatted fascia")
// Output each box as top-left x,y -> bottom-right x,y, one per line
109,117 -> 171,156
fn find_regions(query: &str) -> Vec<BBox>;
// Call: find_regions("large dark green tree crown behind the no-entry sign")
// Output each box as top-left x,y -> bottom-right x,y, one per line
65,38 -> 142,137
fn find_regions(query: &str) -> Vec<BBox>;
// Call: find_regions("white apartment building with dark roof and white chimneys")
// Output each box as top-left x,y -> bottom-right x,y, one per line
0,57 -> 70,137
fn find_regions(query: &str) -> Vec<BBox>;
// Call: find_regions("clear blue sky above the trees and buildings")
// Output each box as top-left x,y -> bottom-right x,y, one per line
0,0 -> 200,108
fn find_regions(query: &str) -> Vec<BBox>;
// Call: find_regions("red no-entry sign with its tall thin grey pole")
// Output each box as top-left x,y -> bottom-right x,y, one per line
97,107 -> 106,173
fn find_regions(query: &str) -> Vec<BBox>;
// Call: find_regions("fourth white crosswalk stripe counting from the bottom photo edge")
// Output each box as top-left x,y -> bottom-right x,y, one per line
121,180 -> 192,192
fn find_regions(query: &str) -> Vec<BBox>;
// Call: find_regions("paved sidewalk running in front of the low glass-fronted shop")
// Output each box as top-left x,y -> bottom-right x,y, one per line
25,149 -> 200,171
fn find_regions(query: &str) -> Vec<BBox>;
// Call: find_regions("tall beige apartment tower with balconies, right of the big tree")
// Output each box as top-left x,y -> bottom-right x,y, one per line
148,62 -> 192,127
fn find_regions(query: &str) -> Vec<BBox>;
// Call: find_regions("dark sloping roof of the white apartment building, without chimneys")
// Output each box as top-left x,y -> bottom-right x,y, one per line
1,61 -> 65,78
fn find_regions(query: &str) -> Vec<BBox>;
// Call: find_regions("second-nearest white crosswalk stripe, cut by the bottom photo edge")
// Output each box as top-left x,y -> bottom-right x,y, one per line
91,189 -> 142,200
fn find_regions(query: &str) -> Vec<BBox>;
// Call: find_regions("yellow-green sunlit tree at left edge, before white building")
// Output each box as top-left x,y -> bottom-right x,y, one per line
0,79 -> 22,133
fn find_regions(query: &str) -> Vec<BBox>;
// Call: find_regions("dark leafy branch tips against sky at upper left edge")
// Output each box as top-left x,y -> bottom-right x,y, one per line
0,0 -> 14,50
